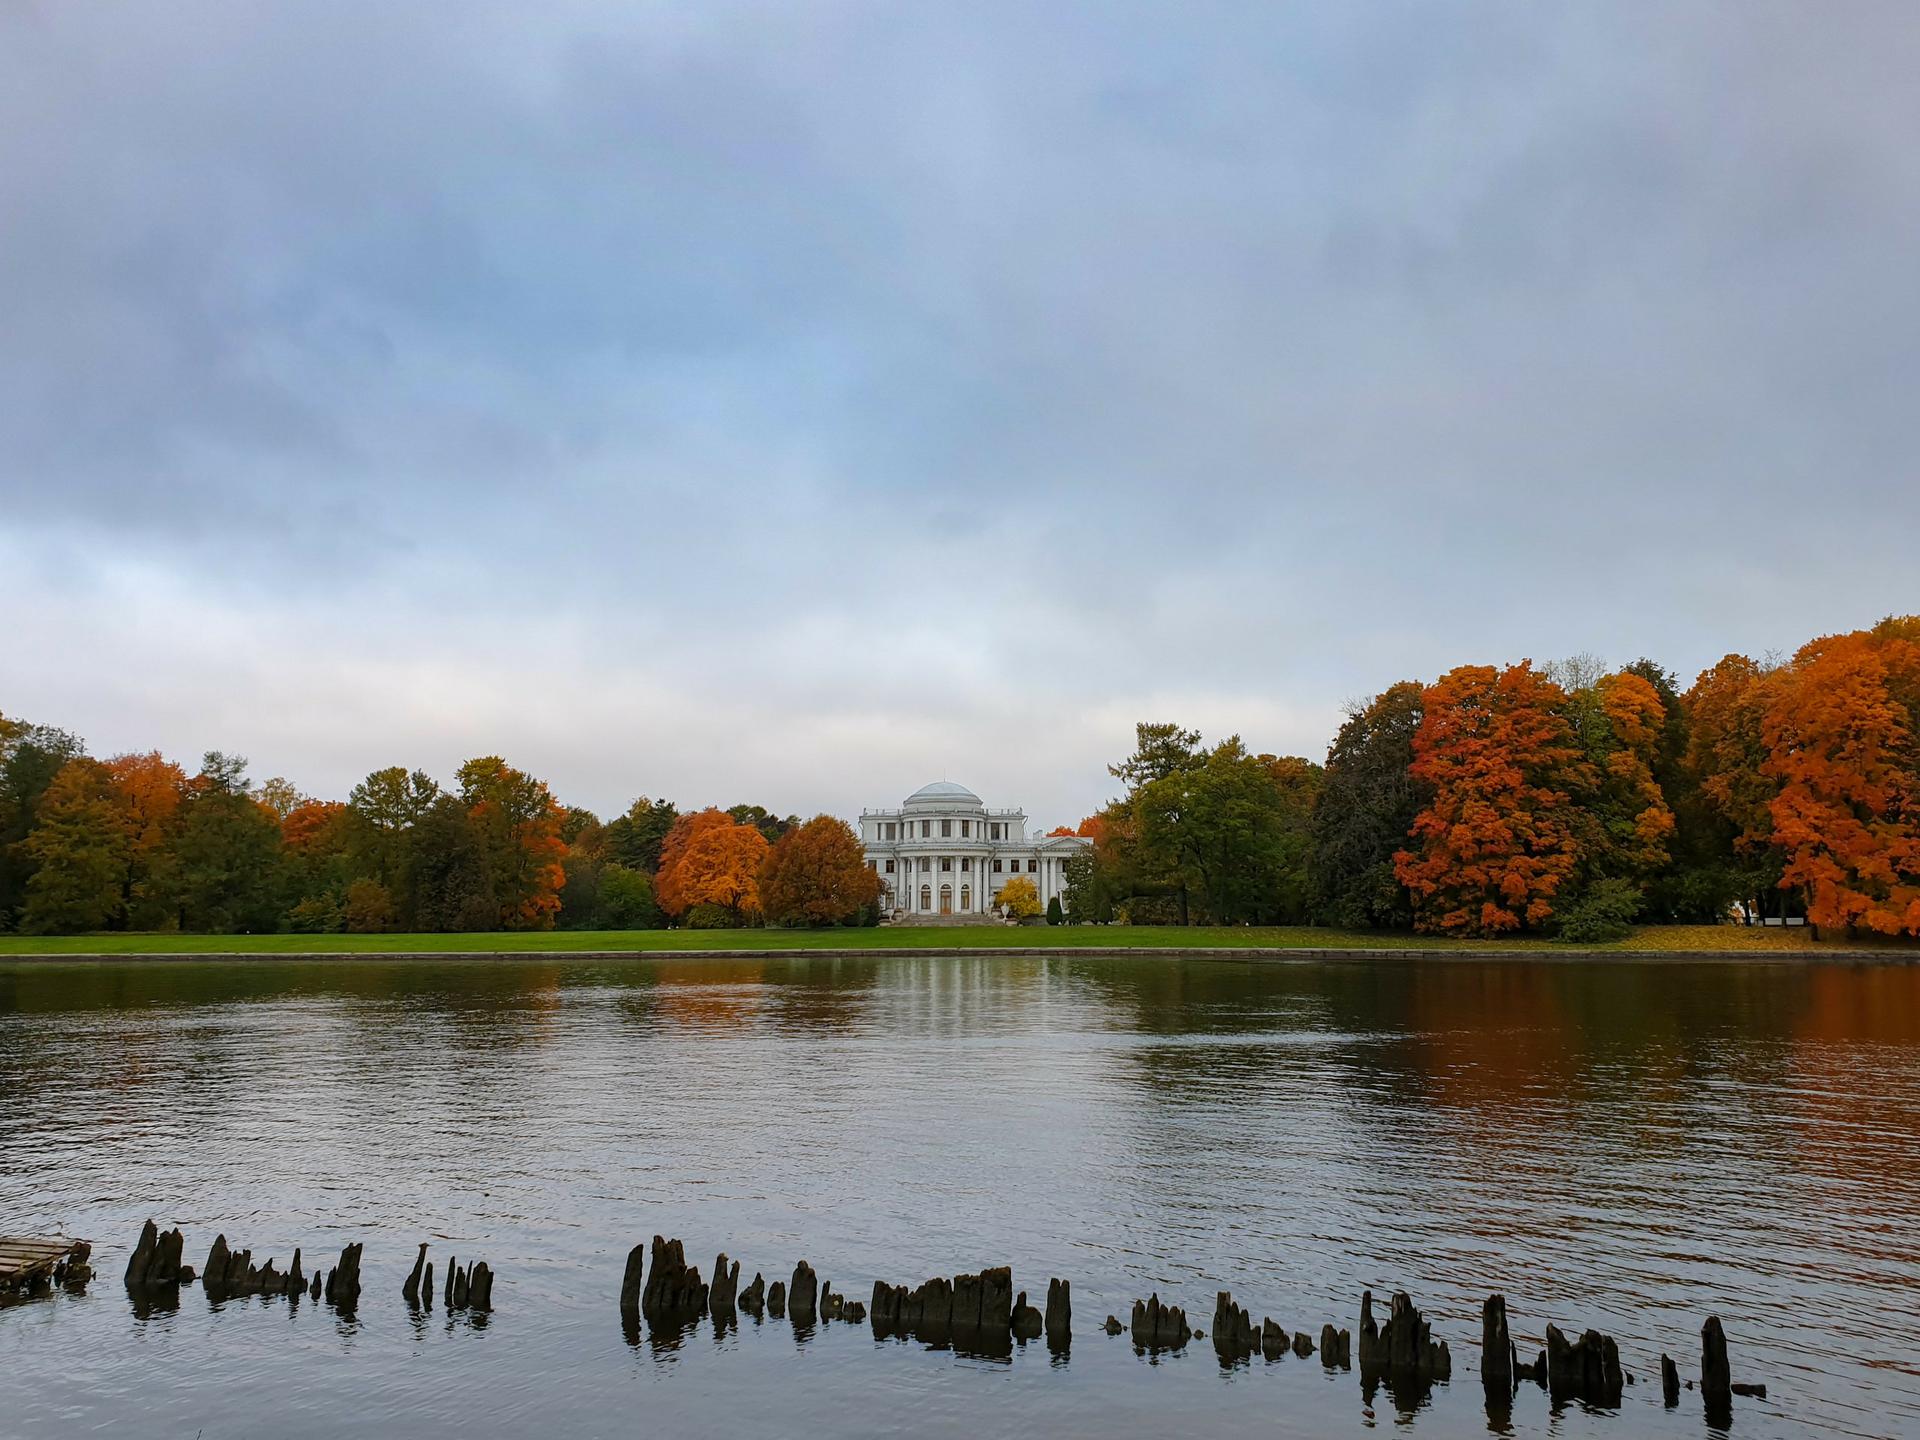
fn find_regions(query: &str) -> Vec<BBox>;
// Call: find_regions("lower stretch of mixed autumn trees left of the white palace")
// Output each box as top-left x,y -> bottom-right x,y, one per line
0,733 -> 879,935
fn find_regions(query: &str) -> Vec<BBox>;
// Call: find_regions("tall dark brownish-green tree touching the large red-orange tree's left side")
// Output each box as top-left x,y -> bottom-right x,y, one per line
1311,680 -> 1432,929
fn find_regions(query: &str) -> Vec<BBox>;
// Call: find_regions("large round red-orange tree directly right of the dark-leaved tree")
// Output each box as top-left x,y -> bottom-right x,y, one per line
1394,662 -> 1592,935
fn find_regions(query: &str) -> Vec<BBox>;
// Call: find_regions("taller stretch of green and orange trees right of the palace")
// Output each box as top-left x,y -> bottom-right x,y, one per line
1068,616 -> 1920,941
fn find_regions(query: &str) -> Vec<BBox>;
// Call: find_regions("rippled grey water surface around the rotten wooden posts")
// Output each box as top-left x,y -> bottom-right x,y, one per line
0,956 -> 1920,1440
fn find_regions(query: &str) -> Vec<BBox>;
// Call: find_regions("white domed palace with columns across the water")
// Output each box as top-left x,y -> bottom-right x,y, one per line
860,780 -> 1092,916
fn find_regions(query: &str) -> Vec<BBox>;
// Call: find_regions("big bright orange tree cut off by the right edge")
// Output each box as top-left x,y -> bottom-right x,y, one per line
1763,616 -> 1920,935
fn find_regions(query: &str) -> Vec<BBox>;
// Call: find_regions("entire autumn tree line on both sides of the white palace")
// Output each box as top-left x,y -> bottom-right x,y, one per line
0,616 -> 1920,941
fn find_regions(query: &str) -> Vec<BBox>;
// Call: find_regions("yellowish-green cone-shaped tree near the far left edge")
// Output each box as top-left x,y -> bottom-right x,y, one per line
19,756 -> 131,935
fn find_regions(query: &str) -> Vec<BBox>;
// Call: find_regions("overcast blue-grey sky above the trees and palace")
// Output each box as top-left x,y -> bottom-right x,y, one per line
0,0 -> 1920,826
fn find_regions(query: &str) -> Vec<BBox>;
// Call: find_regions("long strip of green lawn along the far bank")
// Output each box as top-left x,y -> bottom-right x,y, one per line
0,925 -> 1896,956
